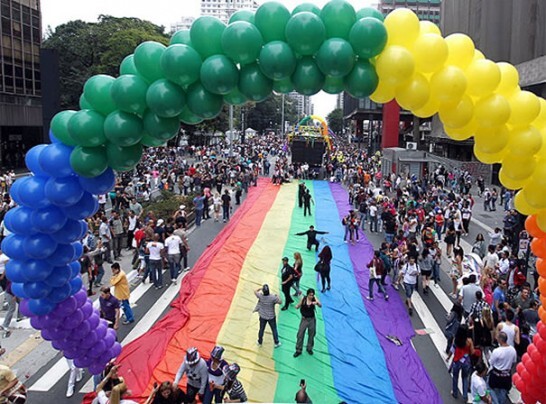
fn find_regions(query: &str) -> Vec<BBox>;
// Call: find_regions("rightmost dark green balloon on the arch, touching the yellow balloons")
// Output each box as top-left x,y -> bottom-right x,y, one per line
349,17 -> 387,59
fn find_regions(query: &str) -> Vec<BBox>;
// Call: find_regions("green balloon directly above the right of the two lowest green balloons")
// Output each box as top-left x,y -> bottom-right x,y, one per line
104,111 -> 143,147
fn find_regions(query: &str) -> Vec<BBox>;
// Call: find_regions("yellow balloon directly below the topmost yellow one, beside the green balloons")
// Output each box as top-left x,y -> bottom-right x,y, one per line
375,45 -> 415,86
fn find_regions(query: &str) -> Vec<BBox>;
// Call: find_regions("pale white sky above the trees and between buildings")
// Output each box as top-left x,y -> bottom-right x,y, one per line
41,0 -> 378,117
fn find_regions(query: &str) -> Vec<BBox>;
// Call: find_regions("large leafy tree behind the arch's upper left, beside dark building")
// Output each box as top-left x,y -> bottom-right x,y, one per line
42,15 -> 169,109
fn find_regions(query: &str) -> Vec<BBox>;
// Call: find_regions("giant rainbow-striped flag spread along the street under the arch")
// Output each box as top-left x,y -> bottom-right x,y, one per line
118,180 -> 441,403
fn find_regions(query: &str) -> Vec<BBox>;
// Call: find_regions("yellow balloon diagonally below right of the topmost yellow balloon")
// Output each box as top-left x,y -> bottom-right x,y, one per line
412,34 -> 448,73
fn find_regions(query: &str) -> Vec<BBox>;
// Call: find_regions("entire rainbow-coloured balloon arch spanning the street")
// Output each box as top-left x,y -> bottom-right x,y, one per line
2,0 -> 546,402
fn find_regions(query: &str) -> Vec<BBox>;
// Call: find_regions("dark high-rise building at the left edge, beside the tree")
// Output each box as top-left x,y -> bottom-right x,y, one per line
0,0 -> 43,169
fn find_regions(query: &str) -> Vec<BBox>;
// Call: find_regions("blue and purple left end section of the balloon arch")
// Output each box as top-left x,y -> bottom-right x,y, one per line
2,136 -> 121,373
